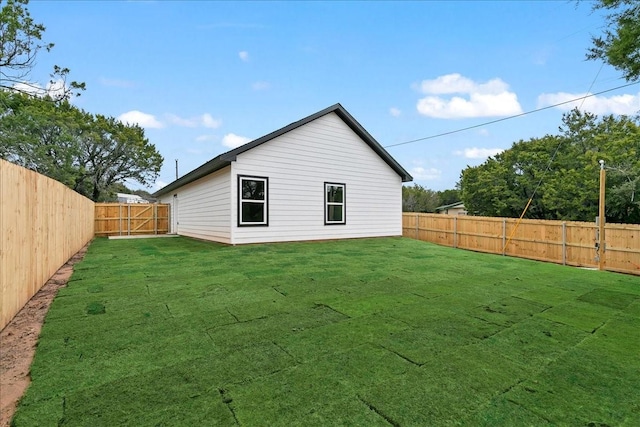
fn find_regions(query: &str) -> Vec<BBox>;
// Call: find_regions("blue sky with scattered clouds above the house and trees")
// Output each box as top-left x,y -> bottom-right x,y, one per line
22,0 -> 640,191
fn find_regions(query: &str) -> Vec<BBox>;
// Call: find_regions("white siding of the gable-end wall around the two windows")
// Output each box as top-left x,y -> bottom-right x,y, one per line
230,113 -> 402,244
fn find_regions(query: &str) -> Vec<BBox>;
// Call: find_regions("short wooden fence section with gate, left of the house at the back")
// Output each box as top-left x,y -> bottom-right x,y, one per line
95,203 -> 169,236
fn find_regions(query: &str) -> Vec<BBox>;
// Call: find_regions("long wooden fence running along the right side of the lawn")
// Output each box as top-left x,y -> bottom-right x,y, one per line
402,212 -> 640,275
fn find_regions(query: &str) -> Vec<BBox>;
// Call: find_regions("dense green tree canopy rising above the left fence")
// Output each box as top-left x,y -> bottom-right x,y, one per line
0,91 -> 163,201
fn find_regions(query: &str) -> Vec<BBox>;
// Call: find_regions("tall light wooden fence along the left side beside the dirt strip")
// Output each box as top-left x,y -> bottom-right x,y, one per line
0,160 -> 94,330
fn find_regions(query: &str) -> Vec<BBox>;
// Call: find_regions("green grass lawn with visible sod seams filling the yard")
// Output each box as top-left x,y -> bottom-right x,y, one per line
13,238 -> 640,427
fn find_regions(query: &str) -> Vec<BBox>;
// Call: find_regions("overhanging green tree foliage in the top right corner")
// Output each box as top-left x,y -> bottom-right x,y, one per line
587,0 -> 640,81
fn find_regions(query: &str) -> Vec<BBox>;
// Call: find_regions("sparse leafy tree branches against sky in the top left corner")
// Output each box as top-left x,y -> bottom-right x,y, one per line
0,0 -> 85,99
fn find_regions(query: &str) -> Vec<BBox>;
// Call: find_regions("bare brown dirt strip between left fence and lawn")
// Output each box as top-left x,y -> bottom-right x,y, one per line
0,245 -> 89,427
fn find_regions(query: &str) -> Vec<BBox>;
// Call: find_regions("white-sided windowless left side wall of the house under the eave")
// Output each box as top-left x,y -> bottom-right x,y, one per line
161,167 -> 231,243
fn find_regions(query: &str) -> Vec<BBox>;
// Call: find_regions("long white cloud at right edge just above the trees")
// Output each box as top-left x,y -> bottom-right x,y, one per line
538,92 -> 640,115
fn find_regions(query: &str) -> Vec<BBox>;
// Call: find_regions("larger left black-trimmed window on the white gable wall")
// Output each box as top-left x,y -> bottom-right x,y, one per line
238,175 -> 269,226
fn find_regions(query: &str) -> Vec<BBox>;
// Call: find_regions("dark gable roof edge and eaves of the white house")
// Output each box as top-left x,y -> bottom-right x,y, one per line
152,104 -> 413,197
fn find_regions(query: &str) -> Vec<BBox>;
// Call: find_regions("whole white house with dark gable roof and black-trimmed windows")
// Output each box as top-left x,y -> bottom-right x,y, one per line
153,104 -> 413,245
